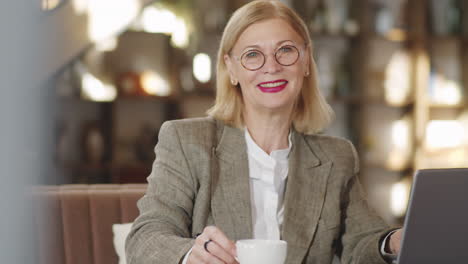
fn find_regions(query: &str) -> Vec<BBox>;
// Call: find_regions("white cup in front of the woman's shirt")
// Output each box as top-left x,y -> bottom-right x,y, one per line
236,239 -> 288,264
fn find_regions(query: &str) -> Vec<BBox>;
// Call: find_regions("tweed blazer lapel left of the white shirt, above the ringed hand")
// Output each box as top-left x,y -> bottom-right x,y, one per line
211,122 -> 253,240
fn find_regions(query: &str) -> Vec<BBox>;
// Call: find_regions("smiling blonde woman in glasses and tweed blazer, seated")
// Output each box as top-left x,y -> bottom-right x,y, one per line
126,1 -> 400,264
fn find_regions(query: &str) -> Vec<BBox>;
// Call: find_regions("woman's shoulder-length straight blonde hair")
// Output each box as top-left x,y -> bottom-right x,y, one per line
207,0 -> 333,134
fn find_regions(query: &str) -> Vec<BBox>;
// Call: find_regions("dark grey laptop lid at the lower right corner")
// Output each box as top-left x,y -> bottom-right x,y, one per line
397,168 -> 468,264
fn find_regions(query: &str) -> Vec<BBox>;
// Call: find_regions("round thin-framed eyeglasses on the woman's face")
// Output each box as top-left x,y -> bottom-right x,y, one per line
240,45 -> 299,71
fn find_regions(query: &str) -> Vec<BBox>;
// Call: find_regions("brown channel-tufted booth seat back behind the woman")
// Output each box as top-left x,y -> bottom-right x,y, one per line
32,184 -> 147,264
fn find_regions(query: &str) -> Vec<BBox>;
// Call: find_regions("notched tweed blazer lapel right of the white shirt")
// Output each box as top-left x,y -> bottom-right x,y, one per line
282,132 -> 332,263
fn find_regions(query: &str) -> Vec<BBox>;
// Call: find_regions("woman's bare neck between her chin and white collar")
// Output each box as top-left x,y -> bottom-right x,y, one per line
244,107 -> 291,154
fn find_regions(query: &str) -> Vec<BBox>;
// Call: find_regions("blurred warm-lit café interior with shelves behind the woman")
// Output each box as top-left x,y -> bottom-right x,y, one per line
15,0 -> 468,227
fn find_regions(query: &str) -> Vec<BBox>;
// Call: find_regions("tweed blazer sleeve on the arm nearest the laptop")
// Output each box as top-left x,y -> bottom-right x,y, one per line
341,142 -> 393,264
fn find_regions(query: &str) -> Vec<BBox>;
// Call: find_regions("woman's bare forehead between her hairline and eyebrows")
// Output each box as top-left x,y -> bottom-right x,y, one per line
233,18 -> 304,50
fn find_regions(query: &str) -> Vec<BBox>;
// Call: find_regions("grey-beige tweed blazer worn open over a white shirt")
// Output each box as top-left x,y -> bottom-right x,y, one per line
126,118 -> 389,264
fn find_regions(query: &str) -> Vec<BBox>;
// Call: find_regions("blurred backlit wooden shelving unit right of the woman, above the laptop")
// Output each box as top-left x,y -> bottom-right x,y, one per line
292,0 -> 468,222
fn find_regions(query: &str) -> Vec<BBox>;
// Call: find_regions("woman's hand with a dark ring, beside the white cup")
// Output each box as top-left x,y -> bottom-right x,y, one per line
187,226 -> 238,264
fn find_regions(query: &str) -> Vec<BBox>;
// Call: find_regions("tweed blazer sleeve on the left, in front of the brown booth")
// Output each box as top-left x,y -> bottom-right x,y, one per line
125,122 -> 196,264
